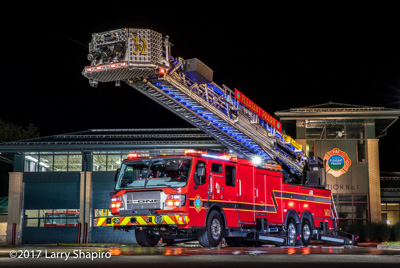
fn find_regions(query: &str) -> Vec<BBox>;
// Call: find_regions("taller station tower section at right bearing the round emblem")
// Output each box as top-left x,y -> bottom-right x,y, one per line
275,102 -> 400,225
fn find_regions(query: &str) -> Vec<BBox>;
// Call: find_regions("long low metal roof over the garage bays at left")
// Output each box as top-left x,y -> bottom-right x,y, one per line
0,128 -> 225,152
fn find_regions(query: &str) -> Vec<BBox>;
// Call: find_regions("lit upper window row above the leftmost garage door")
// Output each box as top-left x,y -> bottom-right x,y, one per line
24,152 -> 82,172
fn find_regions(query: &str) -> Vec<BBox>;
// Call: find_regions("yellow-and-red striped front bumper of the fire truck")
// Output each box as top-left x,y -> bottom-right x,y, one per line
95,214 -> 189,227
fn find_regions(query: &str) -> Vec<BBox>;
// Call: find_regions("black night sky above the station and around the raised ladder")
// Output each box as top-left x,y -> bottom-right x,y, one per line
0,5 -> 400,171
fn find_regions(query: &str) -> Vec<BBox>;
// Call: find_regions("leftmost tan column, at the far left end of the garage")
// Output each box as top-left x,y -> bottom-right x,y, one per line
6,172 -> 24,245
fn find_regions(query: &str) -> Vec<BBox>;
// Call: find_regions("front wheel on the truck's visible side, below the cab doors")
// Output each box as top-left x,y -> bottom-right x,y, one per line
198,210 -> 223,247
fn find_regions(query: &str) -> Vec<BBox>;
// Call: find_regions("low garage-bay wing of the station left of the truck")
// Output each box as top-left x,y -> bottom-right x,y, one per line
0,128 -> 225,244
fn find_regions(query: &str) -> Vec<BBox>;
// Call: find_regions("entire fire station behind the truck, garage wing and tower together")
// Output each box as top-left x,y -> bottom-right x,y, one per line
0,103 -> 400,244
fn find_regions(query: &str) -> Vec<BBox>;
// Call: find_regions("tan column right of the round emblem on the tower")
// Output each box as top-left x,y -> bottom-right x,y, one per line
367,139 -> 381,223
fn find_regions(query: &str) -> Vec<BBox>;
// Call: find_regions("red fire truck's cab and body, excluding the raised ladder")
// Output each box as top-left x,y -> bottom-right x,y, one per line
97,150 -> 357,247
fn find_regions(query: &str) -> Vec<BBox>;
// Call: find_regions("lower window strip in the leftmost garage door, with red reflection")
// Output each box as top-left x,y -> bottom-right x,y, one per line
24,209 -> 79,227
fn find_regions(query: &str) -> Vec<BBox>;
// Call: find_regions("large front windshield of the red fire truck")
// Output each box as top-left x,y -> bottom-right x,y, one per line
115,157 -> 191,190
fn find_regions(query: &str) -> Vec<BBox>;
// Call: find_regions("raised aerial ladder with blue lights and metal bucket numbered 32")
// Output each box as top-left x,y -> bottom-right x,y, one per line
83,29 -> 307,178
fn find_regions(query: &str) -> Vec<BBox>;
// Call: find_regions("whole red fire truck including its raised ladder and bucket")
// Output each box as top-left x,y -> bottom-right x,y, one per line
82,28 -> 356,247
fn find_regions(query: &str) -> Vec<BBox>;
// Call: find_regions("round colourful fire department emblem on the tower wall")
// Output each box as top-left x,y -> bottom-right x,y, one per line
324,148 -> 351,177
